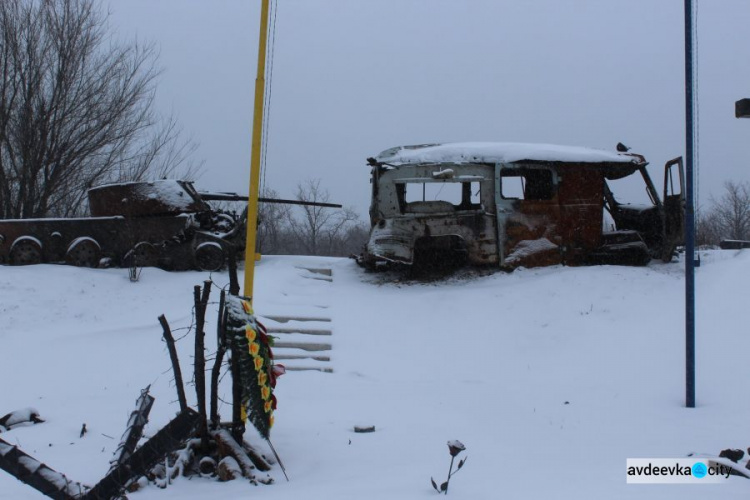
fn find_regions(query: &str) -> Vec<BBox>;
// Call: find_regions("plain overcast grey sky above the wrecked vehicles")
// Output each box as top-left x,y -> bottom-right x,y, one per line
103,0 -> 750,216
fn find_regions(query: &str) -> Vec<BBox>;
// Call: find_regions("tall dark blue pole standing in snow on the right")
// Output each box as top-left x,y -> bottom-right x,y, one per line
685,0 -> 695,408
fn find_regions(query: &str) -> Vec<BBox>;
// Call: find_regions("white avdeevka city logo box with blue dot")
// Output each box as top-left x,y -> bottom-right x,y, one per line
627,458 -> 732,484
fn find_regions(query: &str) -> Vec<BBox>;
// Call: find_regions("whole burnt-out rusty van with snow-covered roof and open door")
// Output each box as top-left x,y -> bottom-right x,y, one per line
359,143 -> 685,269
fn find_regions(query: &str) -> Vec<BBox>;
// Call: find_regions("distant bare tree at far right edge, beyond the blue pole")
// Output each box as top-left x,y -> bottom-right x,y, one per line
710,181 -> 750,240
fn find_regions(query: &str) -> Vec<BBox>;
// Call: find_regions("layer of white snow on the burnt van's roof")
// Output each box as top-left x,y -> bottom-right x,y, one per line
376,142 -> 646,166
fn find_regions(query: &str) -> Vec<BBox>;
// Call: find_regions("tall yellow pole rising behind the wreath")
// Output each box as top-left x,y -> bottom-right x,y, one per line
242,0 -> 269,301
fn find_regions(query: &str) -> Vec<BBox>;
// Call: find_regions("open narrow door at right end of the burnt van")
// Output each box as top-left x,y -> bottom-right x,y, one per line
662,157 -> 685,262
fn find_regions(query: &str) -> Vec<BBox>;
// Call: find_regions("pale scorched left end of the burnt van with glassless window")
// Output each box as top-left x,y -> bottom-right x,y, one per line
367,163 -> 497,270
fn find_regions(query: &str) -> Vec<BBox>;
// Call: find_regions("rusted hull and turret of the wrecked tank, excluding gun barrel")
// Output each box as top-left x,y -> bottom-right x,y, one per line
0,180 -> 245,271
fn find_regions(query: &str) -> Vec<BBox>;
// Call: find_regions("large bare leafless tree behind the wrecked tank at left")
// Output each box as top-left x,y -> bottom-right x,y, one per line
0,0 -> 200,218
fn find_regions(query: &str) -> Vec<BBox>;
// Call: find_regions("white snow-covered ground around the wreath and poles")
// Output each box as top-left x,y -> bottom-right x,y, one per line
0,251 -> 750,500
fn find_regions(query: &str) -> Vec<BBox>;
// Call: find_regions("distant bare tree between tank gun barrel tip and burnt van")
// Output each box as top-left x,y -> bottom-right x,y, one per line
287,179 -> 358,255
